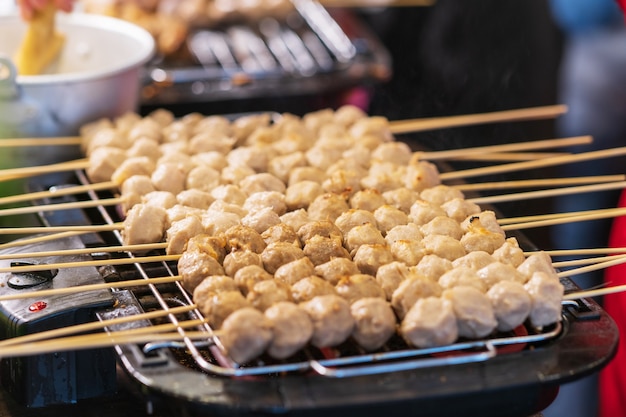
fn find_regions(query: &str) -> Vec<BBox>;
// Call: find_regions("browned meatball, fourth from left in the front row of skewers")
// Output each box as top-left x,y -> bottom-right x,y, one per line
350,297 -> 396,351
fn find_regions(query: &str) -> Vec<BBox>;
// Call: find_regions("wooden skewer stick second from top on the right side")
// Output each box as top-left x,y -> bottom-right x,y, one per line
415,136 -> 593,161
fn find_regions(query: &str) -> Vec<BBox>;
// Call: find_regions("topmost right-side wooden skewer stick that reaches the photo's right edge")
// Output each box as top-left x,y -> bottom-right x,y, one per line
439,146 -> 626,181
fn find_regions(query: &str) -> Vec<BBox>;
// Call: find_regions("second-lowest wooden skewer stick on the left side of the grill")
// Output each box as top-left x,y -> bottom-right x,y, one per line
0,305 -> 195,347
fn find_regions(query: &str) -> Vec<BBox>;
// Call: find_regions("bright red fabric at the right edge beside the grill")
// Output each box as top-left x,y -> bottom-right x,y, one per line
599,189 -> 626,417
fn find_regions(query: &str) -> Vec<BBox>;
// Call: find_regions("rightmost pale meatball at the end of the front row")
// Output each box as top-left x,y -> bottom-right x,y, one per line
524,271 -> 564,328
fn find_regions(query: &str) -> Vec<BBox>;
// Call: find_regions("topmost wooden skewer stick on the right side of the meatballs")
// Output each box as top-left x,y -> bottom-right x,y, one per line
389,104 -> 567,134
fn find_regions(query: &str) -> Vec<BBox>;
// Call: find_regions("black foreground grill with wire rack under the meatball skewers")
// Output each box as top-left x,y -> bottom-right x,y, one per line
2,162 -> 618,416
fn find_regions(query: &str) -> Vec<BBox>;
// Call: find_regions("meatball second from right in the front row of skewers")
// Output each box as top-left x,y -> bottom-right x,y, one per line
487,281 -> 532,331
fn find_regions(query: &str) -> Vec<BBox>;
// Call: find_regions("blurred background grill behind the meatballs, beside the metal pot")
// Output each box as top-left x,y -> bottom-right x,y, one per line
142,0 -> 391,107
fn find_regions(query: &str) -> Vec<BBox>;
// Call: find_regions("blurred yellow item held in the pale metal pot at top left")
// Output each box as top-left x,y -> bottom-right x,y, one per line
15,2 -> 65,75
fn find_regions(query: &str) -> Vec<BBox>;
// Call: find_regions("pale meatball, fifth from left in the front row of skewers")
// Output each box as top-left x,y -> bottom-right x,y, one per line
400,297 -> 459,348
